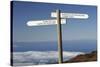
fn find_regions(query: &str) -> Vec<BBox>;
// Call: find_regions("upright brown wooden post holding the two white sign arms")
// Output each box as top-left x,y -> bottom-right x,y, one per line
56,10 -> 63,64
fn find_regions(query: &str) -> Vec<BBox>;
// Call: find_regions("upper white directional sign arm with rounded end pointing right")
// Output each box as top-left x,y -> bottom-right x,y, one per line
51,12 -> 89,19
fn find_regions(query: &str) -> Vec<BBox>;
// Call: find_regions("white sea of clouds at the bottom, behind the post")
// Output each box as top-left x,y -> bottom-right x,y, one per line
13,51 -> 84,66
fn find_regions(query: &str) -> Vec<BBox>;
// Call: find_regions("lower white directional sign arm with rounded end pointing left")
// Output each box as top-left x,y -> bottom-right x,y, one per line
27,19 -> 66,26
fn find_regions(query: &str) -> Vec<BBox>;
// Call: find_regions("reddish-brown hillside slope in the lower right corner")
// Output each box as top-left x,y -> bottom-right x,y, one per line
64,51 -> 97,63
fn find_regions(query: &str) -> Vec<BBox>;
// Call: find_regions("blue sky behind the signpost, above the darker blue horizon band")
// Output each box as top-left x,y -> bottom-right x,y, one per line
12,1 -> 97,42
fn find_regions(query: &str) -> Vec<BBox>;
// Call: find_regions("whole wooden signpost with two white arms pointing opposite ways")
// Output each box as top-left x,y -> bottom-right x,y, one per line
27,10 -> 89,64
